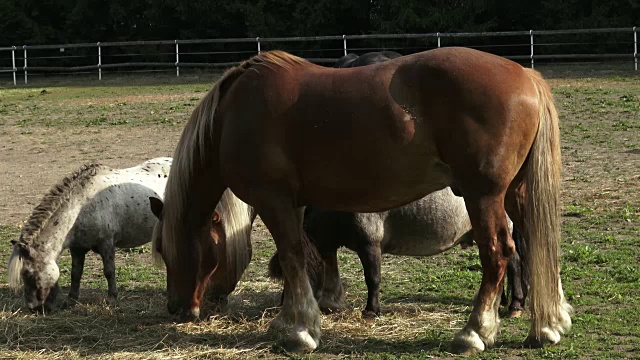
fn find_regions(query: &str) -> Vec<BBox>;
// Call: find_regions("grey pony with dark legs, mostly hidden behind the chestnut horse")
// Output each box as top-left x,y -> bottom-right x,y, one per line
269,187 -> 528,317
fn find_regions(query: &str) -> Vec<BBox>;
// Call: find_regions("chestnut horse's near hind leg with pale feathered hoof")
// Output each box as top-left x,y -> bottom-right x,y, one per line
452,196 -> 515,354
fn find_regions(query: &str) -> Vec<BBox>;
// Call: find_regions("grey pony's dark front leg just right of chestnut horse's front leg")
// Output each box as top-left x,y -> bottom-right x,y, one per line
318,249 -> 344,312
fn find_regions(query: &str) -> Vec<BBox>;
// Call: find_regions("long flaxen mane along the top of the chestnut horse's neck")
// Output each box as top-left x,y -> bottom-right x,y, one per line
162,51 -> 311,263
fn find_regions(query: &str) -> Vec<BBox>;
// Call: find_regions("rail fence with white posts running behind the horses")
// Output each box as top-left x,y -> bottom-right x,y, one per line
0,27 -> 638,85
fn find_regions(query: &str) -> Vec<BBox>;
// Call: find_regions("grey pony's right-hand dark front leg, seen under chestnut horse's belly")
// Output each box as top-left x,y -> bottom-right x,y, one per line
358,244 -> 382,318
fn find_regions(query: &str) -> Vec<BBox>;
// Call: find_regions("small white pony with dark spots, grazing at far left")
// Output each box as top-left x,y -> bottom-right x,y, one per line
8,158 -> 171,311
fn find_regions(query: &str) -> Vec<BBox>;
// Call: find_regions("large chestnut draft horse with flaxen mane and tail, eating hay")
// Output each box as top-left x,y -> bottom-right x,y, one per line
159,47 -> 571,353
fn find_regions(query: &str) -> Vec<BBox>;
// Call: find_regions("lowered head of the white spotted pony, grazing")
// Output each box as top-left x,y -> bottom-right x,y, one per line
9,241 -> 60,312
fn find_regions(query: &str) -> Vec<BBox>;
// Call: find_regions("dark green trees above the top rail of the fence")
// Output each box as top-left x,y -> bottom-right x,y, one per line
0,0 -> 640,46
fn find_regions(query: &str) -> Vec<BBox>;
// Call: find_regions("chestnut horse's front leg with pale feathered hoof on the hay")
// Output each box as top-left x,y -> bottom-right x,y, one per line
256,201 -> 321,352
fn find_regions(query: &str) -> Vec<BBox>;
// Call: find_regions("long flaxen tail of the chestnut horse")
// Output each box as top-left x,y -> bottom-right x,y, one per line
522,69 -> 568,338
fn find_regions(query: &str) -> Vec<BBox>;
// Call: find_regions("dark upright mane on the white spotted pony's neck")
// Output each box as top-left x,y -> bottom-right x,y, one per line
19,163 -> 105,245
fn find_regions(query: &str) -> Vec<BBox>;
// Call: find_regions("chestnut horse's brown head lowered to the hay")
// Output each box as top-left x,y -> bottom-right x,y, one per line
149,197 -> 226,321
